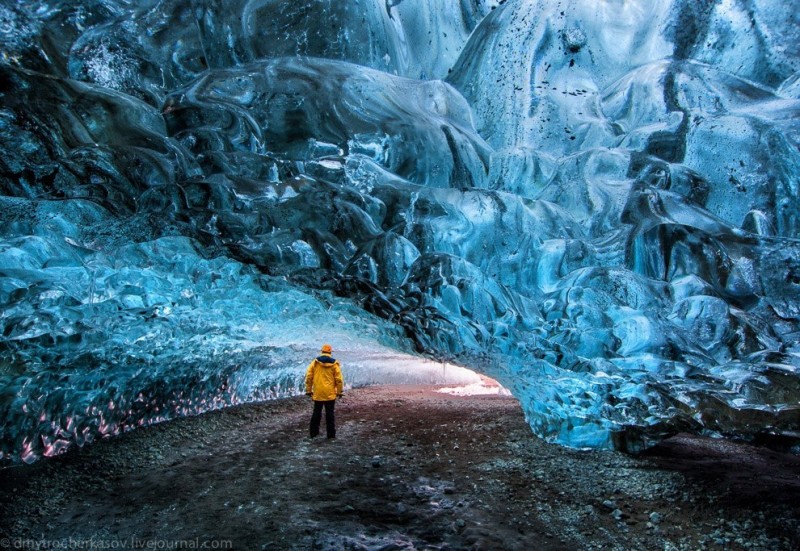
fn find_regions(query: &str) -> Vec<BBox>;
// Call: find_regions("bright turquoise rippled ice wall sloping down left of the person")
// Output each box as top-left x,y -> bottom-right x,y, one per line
0,198 -> 424,465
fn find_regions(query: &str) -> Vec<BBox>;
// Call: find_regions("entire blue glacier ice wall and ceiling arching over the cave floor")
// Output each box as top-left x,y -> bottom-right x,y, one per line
0,0 -> 800,463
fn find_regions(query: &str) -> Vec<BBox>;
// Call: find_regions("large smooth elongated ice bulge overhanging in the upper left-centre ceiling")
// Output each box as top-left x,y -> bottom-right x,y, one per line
164,58 -> 489,188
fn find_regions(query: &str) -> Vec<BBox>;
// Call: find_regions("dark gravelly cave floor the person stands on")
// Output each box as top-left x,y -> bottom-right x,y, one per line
0,386 -> 800,551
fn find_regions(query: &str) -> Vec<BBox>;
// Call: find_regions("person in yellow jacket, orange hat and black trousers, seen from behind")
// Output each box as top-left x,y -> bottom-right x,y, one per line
306,344 -> 344,438
